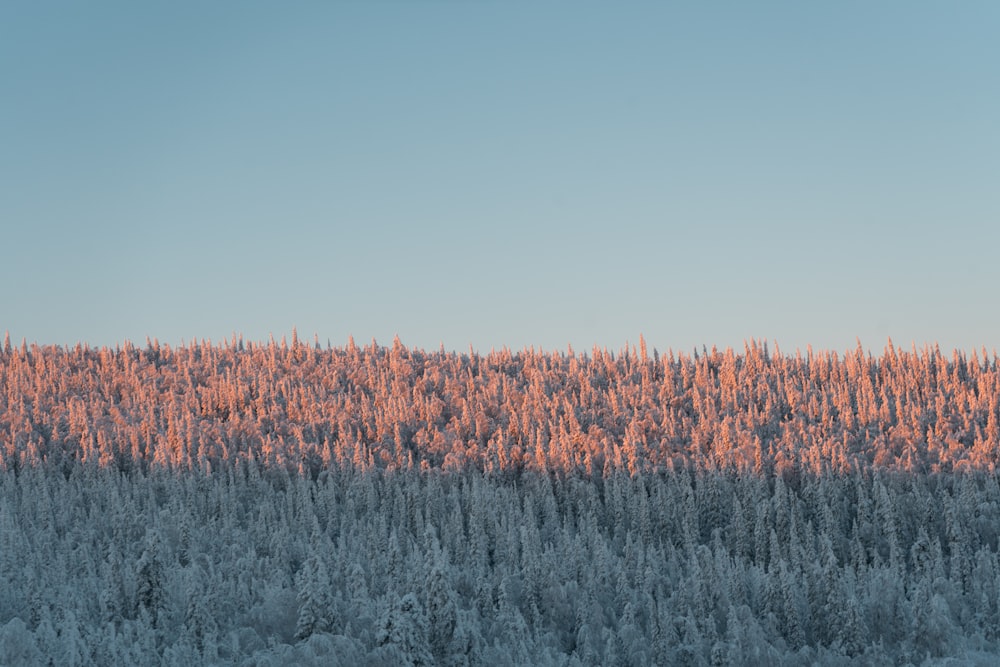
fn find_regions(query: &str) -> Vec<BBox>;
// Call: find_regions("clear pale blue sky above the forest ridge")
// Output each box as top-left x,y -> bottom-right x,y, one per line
0,0 -> 1000,353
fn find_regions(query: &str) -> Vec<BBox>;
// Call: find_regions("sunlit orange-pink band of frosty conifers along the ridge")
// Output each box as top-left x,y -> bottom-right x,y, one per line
0,335 -> 1000,477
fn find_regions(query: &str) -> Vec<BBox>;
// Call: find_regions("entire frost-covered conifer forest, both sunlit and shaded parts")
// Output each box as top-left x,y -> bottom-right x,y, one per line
0,332 -> 1000,666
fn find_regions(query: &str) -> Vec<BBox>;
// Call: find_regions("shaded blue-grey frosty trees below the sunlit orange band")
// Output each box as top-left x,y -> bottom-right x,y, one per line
0,466 -> 1000,666
